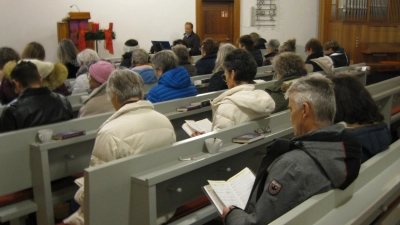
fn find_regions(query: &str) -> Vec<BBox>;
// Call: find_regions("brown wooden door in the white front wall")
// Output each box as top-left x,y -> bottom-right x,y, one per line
202,2 -> 235,44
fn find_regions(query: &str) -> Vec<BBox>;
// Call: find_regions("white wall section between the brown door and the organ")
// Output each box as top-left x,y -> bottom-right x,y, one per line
240,0 -> 319,58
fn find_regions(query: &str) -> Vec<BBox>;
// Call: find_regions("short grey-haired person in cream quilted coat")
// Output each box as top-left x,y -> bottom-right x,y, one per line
64,69 -> 176,225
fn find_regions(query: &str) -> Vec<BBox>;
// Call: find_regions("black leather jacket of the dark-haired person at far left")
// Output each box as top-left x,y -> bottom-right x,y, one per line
0,87 -> 73,132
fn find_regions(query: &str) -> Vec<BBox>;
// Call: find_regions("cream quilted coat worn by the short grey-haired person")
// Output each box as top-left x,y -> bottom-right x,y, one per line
64,101 -> 176,225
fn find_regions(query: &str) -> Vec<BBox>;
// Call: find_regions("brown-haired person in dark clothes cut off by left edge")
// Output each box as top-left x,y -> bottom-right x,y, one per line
0,47 -> 20,105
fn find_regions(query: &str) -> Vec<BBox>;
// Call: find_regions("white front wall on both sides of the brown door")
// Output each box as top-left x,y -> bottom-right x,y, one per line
0,0 -> 318,62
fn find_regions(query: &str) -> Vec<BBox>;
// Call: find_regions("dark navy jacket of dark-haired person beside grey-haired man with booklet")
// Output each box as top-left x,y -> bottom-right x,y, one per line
347,123 -> 392,163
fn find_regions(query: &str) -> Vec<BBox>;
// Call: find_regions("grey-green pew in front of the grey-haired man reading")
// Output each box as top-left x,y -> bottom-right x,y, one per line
85,83 -> 400,224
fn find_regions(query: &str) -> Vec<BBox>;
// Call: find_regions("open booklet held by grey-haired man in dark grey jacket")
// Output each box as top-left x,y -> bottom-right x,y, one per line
203,167 -> 256,215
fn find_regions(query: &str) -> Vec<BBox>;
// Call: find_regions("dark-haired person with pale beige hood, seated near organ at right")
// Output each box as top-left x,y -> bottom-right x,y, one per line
305,38 -> 333,75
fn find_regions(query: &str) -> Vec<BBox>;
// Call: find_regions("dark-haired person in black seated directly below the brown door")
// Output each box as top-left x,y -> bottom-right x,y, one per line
195,38 -> 219,75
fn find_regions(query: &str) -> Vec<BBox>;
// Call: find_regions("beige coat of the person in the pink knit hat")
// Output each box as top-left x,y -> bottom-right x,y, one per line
78,82 -> 115,117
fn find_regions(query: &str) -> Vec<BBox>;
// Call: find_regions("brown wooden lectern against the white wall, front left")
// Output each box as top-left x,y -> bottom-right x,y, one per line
57,12 -> 95,50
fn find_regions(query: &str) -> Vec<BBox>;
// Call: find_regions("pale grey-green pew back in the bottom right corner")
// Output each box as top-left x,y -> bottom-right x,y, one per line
271,140 -> 400,225
